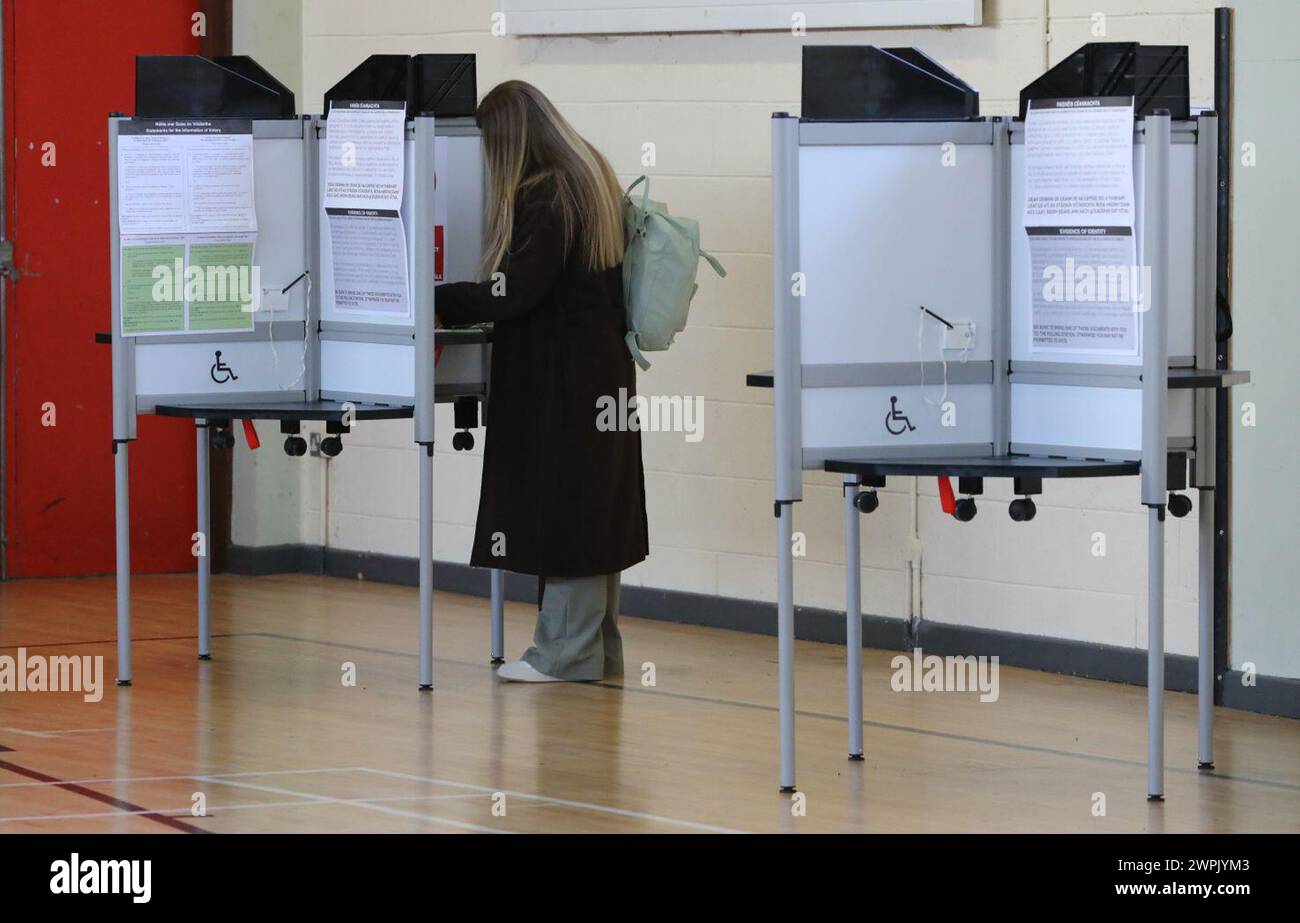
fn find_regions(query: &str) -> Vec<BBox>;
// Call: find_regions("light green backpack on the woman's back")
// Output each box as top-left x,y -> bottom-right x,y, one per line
623,177 -> 727,371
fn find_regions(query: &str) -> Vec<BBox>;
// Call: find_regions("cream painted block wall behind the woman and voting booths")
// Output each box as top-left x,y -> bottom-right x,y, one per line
282,0 -> 1214,653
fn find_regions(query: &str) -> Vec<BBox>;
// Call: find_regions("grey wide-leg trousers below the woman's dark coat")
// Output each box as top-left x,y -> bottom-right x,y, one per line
524,573 -> 623,680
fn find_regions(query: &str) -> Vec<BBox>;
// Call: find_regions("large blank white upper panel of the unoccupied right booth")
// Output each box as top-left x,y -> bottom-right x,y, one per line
798,144 -> 993,364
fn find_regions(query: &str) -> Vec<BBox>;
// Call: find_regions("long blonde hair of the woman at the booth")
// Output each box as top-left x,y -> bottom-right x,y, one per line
475,81 -> 624,278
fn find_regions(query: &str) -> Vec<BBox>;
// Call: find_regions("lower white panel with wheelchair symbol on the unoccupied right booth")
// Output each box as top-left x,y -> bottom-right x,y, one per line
802,385 -> 993,450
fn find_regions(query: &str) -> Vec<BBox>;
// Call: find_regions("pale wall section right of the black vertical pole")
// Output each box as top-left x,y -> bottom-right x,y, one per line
1229,0 -> 1300,677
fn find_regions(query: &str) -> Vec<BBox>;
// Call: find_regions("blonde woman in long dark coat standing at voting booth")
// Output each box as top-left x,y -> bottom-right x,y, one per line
436,81 -> 649,683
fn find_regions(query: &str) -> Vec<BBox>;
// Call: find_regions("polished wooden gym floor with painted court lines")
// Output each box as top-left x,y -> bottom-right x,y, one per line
0,575 -> 1300,833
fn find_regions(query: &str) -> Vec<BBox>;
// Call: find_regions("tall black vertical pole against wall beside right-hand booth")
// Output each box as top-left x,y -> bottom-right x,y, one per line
1214,7 -> 1235,705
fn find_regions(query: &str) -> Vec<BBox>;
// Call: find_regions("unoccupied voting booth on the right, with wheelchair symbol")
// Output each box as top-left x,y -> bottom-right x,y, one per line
749,43 -> 1247,798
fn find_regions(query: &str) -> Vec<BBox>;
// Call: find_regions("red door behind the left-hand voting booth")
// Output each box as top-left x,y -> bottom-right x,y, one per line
3,0 -> 199,577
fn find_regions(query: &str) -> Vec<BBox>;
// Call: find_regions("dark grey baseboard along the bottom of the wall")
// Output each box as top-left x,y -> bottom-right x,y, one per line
226,545 -> 1300,718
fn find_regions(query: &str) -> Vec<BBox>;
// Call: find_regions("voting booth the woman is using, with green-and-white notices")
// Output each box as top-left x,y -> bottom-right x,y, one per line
108,55 -> 503,689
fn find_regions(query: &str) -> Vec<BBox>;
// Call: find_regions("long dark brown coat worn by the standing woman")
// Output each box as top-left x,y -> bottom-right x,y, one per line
434,175 -> 649,577
